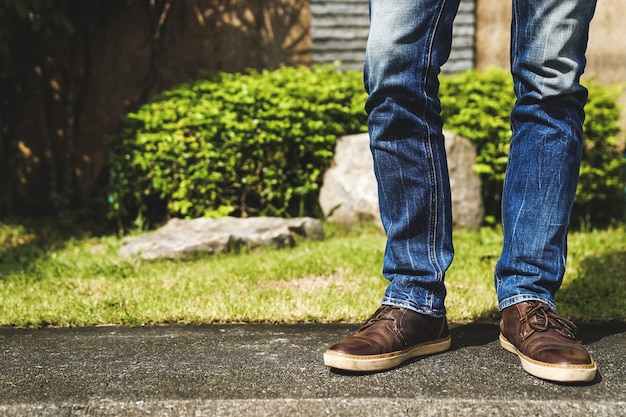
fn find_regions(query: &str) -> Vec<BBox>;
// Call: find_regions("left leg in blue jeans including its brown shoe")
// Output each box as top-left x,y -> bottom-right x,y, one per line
324,0 -> 459,370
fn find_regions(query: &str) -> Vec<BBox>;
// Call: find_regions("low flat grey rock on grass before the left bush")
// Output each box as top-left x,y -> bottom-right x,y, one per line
120,217 -> 324,259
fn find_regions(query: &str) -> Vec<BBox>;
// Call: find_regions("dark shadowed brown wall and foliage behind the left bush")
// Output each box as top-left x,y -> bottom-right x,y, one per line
0,0 -> 310,218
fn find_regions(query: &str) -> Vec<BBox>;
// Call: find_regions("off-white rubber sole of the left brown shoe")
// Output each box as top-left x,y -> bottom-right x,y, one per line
324,336 -> 452,372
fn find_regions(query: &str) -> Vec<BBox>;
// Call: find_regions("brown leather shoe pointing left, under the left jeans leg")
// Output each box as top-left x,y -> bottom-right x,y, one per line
324,305 -> 450,371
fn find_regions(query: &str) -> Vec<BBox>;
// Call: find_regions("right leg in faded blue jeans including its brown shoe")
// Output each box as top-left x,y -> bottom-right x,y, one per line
495,0 -> 595,381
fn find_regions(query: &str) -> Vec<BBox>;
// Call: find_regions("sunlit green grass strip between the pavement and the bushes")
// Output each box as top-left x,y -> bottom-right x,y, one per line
0,222 -> 626,327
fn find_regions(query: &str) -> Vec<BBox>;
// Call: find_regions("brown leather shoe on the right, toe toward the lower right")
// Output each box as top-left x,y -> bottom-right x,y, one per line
500,301 -> 596,382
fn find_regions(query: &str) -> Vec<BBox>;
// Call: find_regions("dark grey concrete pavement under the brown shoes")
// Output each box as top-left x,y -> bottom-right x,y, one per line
0,323 -> 626,416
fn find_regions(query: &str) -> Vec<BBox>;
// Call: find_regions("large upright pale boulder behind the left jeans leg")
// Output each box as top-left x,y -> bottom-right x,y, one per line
319,132 -> 484,229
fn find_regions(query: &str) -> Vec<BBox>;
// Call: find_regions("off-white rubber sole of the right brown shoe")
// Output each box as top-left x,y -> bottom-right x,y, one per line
500,333 -> 597,382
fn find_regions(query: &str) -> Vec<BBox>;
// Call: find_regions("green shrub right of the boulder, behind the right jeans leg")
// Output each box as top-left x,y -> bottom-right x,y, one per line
440,69 -> 624,224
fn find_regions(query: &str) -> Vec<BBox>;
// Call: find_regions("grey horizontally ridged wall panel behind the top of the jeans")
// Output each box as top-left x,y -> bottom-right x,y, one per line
311,0 -> 476,73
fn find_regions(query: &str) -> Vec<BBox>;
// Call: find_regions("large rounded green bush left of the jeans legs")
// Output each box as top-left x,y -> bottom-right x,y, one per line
109,66 -> 366,228
